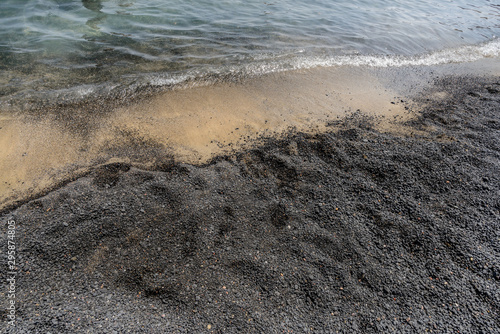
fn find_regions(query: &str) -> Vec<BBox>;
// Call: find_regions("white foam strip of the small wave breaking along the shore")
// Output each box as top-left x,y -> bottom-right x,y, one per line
72,39 -> 500,97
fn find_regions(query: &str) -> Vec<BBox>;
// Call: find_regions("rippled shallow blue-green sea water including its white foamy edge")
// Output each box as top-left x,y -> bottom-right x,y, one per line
0,0 -> 500,100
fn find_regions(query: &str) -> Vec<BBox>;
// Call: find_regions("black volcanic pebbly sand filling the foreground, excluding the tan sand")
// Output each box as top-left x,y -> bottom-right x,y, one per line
1,77 -> 500,333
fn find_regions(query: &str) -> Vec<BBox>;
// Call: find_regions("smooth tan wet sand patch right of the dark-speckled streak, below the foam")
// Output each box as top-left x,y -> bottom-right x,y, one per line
112,69 -> 412,163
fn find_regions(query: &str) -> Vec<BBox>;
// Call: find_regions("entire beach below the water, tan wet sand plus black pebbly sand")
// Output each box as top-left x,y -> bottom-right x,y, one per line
0,60 -> 500,333
